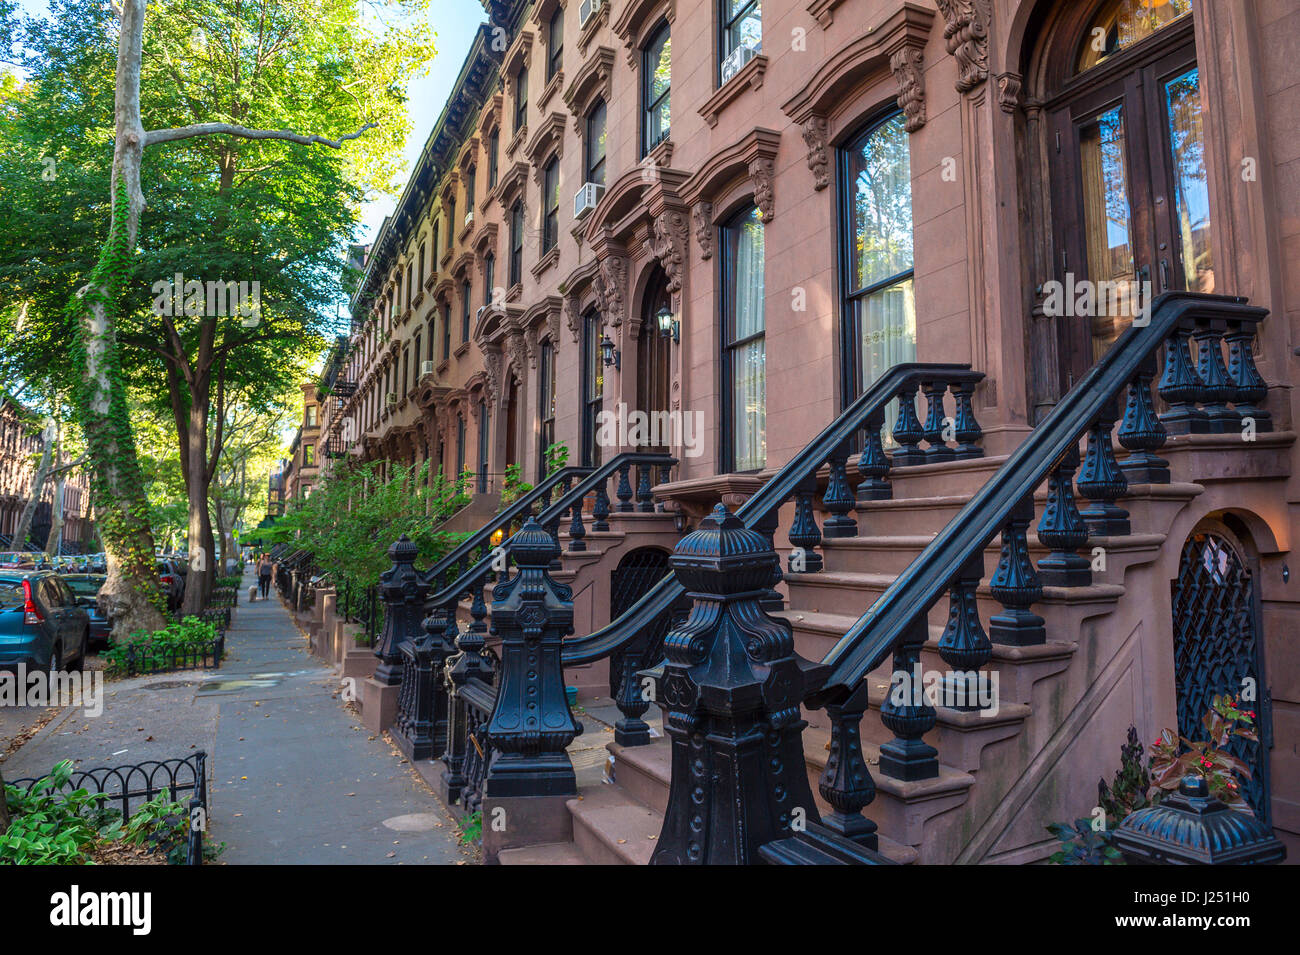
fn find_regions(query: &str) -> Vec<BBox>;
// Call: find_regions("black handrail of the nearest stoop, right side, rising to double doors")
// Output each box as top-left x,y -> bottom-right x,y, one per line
816,292 -> 1268,704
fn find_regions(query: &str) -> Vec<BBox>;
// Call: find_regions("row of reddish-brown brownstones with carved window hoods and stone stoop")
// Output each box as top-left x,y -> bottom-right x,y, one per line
319,0 -> 1300,861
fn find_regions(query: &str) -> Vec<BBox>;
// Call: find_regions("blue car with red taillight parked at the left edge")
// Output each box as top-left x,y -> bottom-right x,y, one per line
0,570 -> 90,670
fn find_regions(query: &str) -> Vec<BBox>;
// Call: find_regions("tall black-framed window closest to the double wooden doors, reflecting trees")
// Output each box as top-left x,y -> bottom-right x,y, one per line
840,113 -> 917,407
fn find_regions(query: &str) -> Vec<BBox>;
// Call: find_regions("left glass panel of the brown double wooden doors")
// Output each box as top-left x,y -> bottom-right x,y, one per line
1067,107 -> 1139,361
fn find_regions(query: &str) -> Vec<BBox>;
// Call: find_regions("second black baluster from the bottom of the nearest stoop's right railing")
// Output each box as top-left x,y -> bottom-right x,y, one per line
880,613 -> 939,781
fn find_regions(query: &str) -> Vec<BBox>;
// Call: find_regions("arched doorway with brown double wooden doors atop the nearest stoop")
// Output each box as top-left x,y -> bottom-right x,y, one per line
1040,0 -> 1216,394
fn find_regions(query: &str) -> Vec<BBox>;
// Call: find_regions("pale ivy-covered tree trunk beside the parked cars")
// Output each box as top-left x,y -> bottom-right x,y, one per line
70,0 -> 165,641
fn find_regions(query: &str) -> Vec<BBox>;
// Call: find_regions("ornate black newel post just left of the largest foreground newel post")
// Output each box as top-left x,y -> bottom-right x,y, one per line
484,517 -> 582,799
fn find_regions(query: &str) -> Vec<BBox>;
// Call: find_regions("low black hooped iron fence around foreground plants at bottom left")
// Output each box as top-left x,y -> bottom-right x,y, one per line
8,750 -> 208,865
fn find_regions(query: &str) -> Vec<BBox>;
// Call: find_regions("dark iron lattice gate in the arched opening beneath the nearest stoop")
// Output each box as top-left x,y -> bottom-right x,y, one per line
1173,531 -> 1273,822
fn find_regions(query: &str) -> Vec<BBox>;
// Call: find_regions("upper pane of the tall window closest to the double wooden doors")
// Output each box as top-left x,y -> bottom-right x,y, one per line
849,113 -> 913,288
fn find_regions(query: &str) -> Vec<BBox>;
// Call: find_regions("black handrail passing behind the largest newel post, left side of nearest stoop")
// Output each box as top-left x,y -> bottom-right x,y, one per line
562,363 -> 984,667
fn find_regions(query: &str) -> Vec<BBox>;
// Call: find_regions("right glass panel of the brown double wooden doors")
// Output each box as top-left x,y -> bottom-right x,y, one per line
1165,68 -> 1214,292
